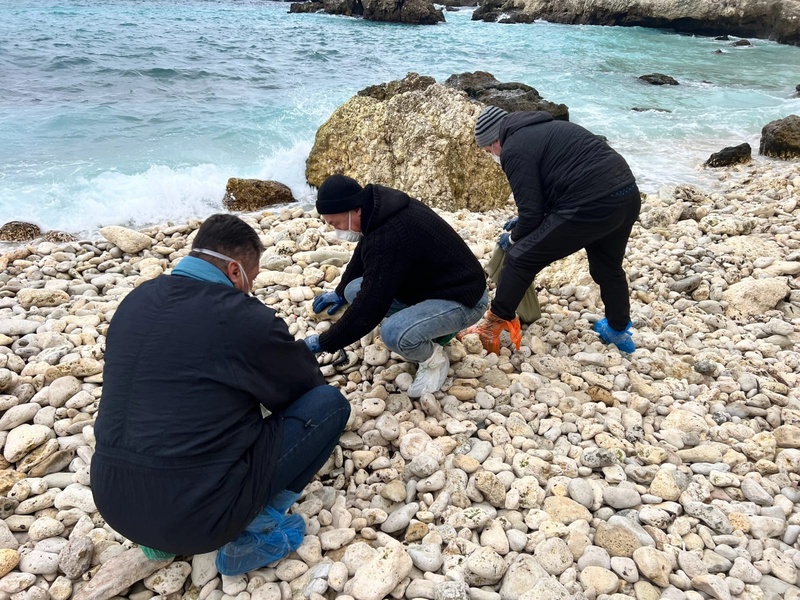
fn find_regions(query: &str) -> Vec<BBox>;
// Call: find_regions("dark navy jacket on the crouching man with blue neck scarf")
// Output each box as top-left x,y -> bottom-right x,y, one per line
91,275 -> 325,554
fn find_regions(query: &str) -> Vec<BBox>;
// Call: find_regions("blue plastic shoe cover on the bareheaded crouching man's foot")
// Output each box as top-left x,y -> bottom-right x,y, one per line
216,512 -> 306,575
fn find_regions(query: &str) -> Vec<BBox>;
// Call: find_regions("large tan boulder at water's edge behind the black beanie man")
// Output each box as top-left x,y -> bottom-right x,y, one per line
306,73 -> 510,211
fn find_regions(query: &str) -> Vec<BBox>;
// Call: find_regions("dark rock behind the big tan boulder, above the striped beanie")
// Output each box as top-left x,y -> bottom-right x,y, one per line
444,71 -> 569,121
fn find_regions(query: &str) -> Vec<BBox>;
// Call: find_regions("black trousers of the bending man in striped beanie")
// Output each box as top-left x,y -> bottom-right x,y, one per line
492,191 -> 642,331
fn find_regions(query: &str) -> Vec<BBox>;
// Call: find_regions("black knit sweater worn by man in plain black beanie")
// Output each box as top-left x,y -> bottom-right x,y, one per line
319,185 -> 486,352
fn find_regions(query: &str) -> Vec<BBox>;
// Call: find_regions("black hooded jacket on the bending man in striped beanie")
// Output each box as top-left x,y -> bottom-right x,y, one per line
500,112 -> 635,241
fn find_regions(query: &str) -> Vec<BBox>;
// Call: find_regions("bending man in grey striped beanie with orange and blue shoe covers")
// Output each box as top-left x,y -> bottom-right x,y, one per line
465,106 -> 641,352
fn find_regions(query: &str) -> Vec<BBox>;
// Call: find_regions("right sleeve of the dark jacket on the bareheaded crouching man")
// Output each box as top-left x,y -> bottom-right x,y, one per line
231,298 -> 326,411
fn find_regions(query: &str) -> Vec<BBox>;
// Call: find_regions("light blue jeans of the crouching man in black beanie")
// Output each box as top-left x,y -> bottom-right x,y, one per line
344,277 -> 489,362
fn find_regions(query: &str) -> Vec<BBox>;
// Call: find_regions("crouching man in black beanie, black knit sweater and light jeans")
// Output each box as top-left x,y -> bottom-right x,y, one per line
306,175 -> 488,397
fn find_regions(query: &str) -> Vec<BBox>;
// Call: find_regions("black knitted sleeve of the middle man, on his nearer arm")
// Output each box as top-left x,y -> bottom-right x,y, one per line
319,230 -> 403,352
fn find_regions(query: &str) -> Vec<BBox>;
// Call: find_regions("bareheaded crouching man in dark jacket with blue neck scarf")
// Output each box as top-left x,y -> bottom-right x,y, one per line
91,214 -> 350,575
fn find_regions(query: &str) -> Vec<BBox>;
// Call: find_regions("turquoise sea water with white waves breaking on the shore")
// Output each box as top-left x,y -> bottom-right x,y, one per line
0,0 -> 800,232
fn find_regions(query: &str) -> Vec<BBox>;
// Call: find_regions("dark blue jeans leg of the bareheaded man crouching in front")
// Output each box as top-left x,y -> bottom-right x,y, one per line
268,385 -> 350,492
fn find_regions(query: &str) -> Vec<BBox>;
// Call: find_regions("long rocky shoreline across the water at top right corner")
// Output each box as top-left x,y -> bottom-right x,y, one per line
472,0 -> 800,45
